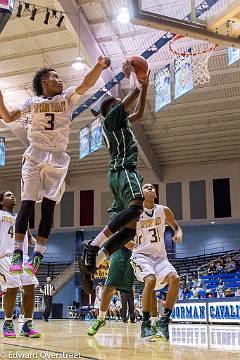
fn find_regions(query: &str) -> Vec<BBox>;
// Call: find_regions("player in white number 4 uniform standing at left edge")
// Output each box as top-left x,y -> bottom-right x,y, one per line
0,191 -> 41,338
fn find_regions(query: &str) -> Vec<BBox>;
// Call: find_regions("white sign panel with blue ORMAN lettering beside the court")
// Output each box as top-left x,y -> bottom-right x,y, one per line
172,302 -> 207,322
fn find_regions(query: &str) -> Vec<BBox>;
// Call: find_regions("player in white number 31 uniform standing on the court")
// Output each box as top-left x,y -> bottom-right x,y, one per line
131,184 -> 183,340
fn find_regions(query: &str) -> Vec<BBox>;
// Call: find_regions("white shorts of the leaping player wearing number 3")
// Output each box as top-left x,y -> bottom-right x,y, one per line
21,146 -> 70,203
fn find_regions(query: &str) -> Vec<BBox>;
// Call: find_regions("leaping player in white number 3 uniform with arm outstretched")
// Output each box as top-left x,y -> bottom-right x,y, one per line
0,56 -> 110,275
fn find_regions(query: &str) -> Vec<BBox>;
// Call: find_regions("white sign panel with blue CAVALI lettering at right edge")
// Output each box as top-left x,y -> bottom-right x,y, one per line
208,301 -> 240,323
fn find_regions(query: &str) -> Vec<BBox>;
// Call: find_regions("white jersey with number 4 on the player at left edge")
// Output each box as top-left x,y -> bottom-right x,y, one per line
0,210 -> 28,258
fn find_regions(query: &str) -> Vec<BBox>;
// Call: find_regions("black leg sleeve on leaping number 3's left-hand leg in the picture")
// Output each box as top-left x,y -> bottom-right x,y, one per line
15,200 -> 35,234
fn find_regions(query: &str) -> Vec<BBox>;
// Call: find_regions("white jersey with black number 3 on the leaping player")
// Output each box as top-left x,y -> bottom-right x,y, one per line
20,87 -> 80,151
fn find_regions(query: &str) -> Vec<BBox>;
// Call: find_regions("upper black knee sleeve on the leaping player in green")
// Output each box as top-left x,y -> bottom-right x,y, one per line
108,205 -> 143,234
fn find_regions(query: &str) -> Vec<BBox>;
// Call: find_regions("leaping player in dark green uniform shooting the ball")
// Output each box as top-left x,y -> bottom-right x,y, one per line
79,72 -> 149,293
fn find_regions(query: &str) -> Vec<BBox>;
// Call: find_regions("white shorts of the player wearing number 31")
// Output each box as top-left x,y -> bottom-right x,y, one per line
131,253 -> 177,290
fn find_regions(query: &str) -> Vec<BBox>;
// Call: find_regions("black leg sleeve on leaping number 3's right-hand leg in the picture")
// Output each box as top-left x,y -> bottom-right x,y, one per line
38,198 -> 56,238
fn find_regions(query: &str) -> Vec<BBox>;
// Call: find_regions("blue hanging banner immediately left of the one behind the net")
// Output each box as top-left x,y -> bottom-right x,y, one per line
154,65 -> 171,112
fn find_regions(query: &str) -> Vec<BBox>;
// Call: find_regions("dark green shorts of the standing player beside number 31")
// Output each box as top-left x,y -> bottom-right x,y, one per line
105,248 -> 134,292
